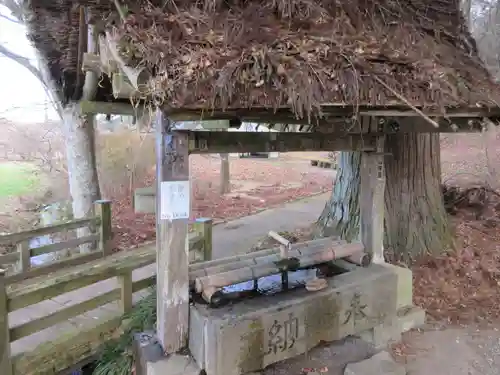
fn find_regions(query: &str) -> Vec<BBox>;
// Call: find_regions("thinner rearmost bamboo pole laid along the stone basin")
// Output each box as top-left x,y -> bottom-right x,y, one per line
189,238 -> 346,281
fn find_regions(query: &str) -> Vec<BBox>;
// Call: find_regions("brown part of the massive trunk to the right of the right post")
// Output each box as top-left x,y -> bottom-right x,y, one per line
385,133 -> 453,260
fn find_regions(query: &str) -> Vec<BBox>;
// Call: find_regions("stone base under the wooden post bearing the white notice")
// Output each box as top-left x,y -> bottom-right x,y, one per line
133,332 -> 201,375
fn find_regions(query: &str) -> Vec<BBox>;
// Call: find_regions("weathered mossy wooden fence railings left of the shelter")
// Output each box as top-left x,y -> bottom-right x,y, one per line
0,202 -> 212,375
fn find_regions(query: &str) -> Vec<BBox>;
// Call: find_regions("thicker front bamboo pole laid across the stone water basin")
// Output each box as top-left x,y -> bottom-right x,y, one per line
195,243 -> 364,293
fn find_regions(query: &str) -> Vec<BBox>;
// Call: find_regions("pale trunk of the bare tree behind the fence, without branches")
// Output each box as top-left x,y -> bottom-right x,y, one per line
63,106 -> 101,252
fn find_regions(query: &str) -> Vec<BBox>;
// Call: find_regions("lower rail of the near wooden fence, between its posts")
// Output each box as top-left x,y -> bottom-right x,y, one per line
10,289 -> 120,341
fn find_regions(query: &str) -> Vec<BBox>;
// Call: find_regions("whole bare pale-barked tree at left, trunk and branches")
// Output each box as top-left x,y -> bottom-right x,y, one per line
0,0 -> 101,251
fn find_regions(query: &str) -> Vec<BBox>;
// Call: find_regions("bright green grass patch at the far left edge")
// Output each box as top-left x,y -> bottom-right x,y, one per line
0,162 -> 39,198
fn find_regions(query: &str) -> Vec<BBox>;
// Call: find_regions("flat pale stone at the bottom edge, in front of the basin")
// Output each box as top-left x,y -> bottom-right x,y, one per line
344,351 -> 406,375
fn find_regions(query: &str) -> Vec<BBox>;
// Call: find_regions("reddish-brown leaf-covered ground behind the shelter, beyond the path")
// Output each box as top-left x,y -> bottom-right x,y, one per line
108,155 -> 333,250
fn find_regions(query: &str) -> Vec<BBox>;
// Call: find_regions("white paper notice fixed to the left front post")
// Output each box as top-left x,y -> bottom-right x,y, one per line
160,181 -> 191,220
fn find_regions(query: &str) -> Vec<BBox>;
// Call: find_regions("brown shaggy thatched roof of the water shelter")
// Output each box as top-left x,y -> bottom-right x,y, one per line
27,0 -> 500,119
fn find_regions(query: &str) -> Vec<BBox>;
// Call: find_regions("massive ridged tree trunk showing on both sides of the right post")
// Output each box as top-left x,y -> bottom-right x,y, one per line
316,133 -> 453,260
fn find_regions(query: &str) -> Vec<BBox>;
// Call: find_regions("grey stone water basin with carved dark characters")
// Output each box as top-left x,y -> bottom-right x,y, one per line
189,264 -> 397,375
